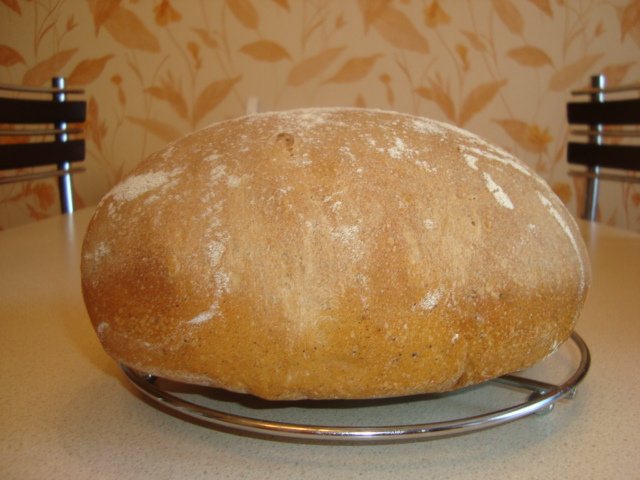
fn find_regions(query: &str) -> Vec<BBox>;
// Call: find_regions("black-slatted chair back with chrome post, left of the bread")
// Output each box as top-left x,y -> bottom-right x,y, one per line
0,77 -> 87,213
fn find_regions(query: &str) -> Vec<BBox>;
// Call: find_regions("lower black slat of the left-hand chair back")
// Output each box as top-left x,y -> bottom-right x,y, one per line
0,140 -> 85,170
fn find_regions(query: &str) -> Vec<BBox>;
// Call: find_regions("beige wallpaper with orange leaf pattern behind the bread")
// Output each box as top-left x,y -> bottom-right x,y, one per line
0,0 -> 640,231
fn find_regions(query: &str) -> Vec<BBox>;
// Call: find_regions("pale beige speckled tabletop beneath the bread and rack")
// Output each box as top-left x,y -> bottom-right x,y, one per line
0,210 -> 640,480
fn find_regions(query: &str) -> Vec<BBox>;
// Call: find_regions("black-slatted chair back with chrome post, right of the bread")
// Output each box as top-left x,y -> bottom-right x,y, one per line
567,75 -> 640,220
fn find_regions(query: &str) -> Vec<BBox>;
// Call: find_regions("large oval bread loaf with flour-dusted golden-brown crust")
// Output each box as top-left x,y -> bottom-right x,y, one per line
82,108 -> 590,399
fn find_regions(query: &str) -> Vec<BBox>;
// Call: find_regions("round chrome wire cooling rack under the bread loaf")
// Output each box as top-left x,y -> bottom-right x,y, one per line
121,332 -> 591,443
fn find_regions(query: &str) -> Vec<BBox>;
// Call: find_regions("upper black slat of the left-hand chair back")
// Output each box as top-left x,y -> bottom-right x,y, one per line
0,98 -> 87,124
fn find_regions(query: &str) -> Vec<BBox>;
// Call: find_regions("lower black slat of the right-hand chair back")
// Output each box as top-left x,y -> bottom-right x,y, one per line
567,142 -> 640,171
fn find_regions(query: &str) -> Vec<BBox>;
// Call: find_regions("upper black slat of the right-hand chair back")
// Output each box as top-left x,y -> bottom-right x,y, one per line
567,98 -> 640,125
